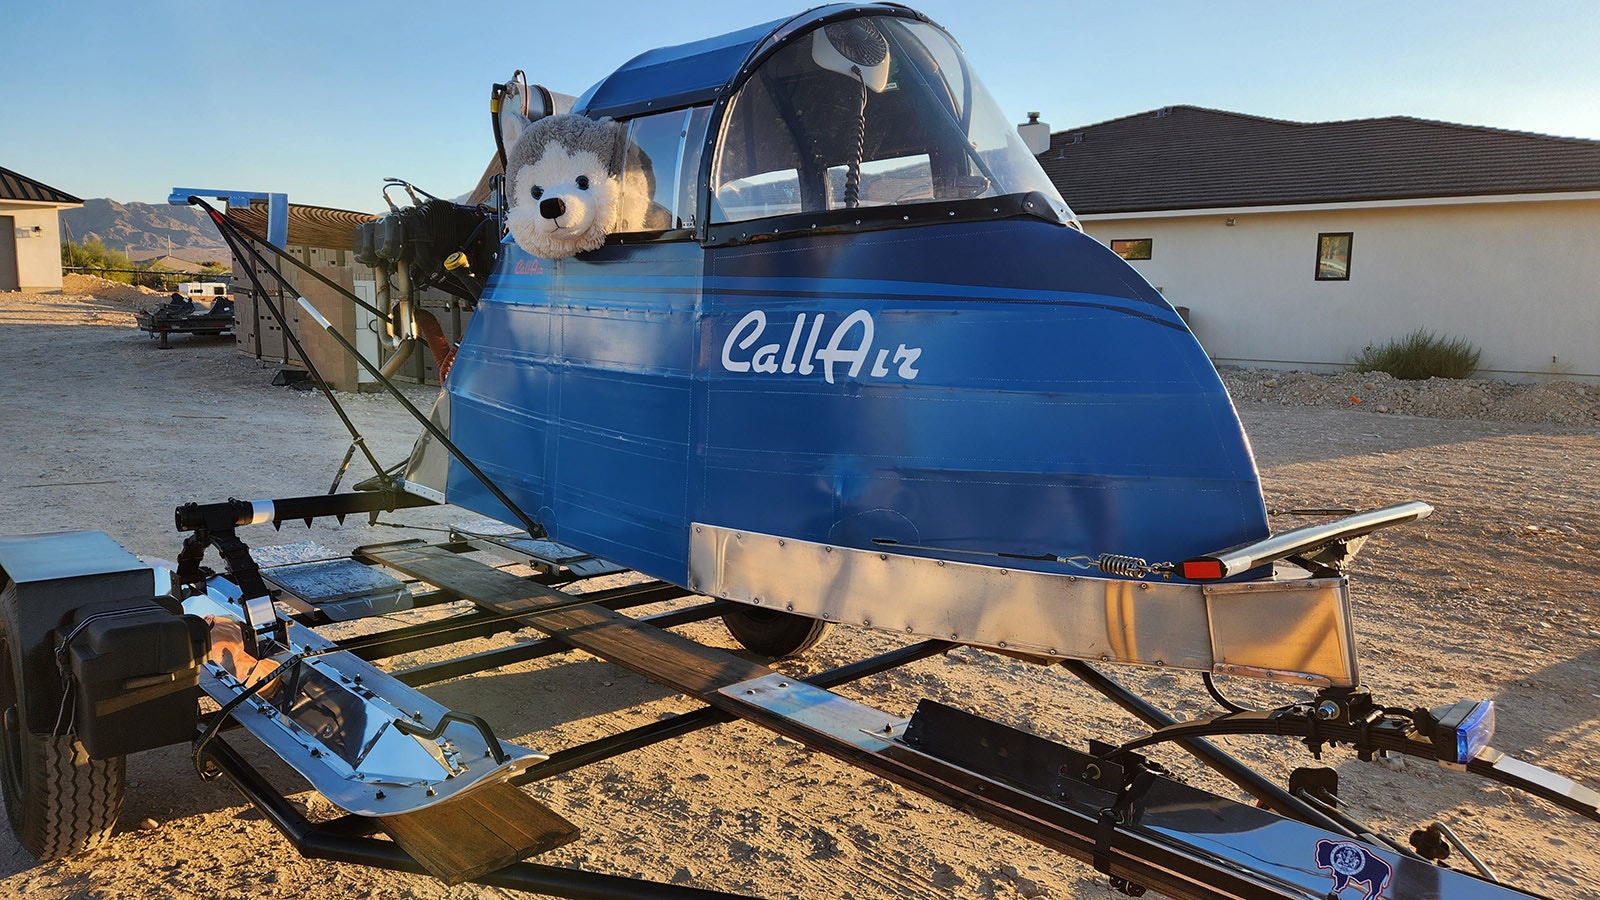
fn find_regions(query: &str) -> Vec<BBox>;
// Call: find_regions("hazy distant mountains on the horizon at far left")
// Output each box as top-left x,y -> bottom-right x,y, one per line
61,197 -> 230,264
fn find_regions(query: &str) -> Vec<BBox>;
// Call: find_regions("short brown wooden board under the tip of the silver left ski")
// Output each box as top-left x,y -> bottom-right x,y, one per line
378,781 -> 581,884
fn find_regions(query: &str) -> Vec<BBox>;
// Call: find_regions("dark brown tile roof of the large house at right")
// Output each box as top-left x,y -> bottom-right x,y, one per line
1038,106 -> 1600,215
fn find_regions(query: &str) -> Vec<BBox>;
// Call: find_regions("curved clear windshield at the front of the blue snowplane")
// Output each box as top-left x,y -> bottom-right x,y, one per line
710,16 -> 1072,223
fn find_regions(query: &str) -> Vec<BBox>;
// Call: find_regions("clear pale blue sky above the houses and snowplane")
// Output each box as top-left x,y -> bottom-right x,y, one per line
0,0 -> 1600,211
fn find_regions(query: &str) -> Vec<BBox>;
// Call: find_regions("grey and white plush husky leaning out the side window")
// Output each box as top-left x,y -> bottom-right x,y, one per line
506,114 -> 670,259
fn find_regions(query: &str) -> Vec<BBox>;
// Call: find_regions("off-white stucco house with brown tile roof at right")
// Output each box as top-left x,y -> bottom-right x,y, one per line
1038,106 -> 1600,381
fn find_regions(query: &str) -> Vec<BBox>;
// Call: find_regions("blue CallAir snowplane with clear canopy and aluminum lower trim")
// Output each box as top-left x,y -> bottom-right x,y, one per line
406,3 -> 1421,682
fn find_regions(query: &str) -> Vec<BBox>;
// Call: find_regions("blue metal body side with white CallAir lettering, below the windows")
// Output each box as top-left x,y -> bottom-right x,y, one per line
446,219 -> 1267,585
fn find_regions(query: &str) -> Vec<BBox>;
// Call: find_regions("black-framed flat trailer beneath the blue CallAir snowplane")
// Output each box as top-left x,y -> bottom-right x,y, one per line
0,492 -> 1600,900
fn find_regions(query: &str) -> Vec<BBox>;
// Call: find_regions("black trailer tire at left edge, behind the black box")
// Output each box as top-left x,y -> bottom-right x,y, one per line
0,604 -> 126,862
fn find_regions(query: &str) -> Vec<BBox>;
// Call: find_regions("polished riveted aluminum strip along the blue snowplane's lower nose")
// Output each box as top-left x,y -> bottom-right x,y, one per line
688,524 -> 1358,685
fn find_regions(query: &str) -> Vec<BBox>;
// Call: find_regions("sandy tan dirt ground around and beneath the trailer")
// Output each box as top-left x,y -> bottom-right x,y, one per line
0,287 -> 1600,900
